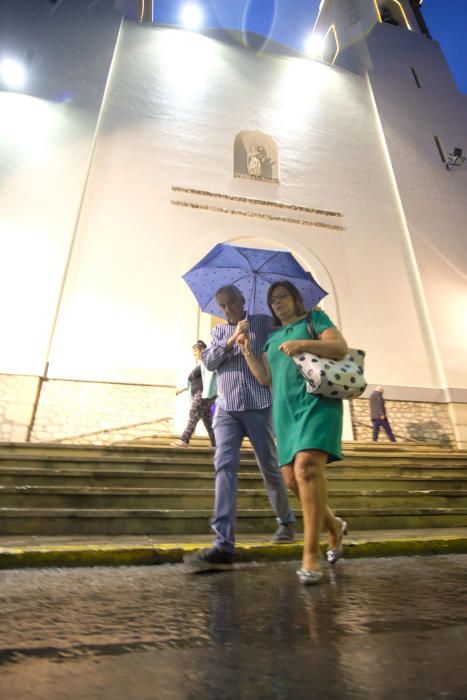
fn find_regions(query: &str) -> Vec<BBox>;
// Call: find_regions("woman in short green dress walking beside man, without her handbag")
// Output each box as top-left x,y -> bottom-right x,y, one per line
238,280 -> 347,585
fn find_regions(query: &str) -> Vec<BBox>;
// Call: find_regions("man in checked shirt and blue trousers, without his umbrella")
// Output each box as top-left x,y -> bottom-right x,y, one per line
185,285 -> 295,569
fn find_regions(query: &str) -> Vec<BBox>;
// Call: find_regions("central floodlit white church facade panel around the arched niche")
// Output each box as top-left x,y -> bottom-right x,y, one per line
38,23 -> 437,400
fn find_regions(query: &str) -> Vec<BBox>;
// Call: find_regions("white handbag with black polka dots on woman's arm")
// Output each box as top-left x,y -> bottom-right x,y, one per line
293,314 -> 366,399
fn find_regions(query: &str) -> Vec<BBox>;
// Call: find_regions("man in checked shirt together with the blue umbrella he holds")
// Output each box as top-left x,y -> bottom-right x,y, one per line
183,243 -> 326,569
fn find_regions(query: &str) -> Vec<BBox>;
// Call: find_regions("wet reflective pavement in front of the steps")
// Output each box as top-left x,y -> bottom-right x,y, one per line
0,554 -> 467,700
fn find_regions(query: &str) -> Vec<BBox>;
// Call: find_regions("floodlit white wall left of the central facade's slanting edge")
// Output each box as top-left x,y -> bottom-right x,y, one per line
0,0 -> 121,374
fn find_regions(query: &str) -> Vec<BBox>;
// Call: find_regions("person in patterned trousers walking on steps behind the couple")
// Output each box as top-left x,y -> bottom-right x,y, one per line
172,340 -> 217,447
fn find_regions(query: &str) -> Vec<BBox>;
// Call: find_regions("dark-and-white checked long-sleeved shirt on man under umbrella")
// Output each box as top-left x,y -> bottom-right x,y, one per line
201,315 -> 272,411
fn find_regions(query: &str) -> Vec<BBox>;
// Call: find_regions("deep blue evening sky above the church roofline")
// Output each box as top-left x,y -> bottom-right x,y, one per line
135,0 -> 467,93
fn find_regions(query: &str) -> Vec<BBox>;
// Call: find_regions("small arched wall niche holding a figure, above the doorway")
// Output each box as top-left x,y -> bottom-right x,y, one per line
234,131 -> 279,183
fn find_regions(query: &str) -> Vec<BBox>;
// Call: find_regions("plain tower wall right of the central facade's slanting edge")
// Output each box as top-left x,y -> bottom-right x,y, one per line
368,25 -> 467,389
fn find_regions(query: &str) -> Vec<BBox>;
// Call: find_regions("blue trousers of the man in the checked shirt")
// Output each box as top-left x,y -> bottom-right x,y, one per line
211,406 -> 295,552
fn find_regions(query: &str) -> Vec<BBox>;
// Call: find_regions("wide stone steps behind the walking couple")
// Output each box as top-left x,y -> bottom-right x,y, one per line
0,438 -> 467,535
